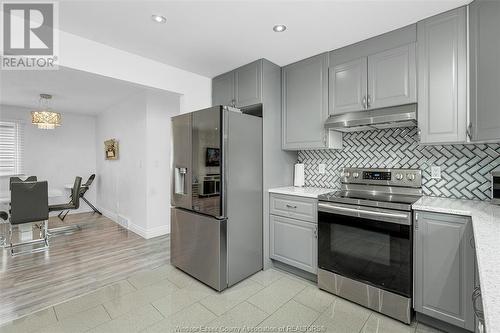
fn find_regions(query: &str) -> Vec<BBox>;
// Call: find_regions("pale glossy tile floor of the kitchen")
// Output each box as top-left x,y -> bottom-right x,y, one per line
0,265 -> 446,333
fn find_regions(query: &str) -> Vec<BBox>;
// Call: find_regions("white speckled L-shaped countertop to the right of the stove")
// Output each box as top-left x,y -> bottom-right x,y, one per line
413,197 -> 500,332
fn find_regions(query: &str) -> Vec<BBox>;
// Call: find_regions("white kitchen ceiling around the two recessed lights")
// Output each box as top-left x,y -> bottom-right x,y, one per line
59,0 -> 471,77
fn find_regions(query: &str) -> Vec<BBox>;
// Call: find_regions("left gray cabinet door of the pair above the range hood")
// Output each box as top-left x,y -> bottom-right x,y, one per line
329,57 -> 368,114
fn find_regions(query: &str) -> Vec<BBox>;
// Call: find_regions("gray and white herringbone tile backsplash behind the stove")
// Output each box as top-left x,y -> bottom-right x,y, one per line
298,128 -> 500,200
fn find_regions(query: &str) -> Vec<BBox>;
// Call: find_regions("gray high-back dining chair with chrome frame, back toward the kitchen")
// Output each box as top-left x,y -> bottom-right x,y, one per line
9,181 -> 49,255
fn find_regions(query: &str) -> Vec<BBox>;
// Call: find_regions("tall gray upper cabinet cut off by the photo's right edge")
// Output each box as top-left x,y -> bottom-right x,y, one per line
469,0 -> 500,141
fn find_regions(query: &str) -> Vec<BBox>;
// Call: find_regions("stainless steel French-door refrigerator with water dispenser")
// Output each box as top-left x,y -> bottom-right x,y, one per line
170,106 -> 262,290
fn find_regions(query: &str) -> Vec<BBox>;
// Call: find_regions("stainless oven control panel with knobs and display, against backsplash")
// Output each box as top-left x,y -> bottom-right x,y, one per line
341,168 -> 422,187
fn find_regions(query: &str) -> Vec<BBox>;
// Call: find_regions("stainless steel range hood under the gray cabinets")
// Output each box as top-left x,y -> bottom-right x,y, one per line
325,104 -> 417,132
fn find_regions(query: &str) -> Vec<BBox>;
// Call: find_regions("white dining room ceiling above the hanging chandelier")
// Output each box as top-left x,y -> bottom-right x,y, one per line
0,67 -> 149,114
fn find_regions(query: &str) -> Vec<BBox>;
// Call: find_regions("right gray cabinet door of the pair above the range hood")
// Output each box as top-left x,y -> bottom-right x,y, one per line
367,43 -> 417,109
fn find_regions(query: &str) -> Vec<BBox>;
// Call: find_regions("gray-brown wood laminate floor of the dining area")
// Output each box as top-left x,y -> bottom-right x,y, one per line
0,213 -> 170,325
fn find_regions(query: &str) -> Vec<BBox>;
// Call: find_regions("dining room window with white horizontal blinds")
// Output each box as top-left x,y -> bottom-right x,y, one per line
0,121 -> 24,176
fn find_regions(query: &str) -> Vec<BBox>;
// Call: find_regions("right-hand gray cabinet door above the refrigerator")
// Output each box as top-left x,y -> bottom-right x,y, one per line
234,61 -> 262,107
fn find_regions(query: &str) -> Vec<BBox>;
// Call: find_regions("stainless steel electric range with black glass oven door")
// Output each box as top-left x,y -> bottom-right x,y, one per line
318,168 -> 422,323
